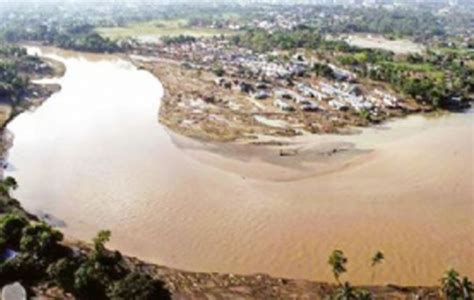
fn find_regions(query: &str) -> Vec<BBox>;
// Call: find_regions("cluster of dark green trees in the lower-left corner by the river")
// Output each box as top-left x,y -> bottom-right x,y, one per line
0,177 -> 170,300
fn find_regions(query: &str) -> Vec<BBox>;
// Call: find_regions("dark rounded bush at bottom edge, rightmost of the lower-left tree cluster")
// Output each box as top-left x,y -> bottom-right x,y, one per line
107,273 -> 171,300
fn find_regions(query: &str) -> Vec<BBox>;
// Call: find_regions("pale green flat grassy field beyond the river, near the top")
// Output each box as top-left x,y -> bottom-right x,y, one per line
96,19 -> 241,41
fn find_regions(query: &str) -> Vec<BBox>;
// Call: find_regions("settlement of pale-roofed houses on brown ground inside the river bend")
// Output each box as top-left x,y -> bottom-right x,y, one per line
131,34 -> 473,141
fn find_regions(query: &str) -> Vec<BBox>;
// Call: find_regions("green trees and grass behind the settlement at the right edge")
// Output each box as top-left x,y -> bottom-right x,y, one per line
337,50 -> 474,108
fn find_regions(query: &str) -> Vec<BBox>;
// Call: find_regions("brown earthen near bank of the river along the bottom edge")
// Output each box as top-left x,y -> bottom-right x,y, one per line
0,195 -> 441,299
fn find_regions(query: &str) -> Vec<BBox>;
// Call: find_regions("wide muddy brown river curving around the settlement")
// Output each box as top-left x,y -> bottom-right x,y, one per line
4,50 -> 474,284
